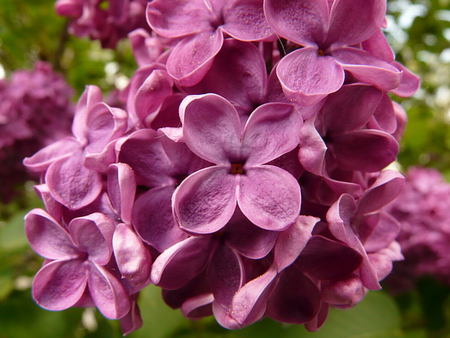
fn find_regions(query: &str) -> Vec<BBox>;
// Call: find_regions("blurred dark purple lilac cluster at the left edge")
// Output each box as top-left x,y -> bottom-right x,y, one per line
0,61 -> 74,203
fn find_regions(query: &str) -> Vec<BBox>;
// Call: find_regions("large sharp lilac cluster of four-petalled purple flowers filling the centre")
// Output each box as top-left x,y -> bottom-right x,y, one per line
24,0 -> 419,334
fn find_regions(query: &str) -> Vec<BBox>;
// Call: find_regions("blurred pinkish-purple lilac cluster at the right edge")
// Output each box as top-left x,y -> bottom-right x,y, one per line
386,167 -> 450,293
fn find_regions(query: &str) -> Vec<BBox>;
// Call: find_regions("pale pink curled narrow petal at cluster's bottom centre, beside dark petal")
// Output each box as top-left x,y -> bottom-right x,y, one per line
231,265 -> 277,325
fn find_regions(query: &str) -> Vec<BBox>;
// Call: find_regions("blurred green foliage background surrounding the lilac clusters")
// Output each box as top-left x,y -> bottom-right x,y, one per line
0,0 -> 450,338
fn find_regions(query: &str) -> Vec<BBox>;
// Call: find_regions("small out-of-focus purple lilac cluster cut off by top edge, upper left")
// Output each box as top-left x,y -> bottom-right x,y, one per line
55,0 -> 148,48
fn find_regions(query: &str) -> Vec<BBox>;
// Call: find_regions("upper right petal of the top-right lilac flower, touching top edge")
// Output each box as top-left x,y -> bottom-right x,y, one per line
327,0 -> 386,46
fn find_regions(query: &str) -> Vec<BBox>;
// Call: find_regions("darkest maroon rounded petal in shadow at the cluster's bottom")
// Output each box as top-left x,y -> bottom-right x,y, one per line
267,267 -> 321,324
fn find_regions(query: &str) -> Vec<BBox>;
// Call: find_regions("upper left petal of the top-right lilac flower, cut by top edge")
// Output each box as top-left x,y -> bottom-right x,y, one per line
264,0 -> 329,46
